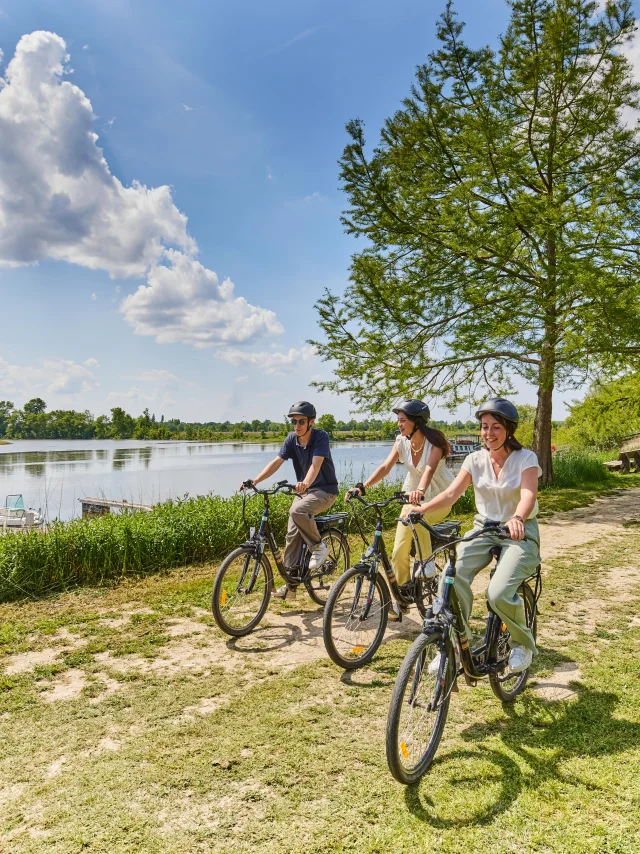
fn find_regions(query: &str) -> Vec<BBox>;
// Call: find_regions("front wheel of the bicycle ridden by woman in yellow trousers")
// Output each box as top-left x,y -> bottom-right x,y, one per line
322,564 -> 391,670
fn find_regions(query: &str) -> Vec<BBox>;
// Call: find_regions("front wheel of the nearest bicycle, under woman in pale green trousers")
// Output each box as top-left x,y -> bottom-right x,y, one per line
386,632 -> 455,785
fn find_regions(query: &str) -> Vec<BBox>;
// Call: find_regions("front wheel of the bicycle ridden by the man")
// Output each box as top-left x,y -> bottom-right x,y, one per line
211,546 -> 273,638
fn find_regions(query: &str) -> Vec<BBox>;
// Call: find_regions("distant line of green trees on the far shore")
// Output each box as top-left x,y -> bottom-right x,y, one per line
0,397 -> 477,441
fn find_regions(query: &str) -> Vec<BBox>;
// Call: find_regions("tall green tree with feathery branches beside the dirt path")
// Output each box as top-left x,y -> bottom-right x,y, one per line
314,0 -> 640,482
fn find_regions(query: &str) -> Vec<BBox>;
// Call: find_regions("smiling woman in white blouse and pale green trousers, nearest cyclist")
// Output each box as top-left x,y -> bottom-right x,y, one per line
420,398 -> 542,673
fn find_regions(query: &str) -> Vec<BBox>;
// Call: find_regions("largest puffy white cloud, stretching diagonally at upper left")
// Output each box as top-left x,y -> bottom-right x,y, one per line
0,31 -> 282,347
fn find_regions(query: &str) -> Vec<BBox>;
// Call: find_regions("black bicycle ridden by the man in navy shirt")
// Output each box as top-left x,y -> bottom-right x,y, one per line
211,480 -> 349,638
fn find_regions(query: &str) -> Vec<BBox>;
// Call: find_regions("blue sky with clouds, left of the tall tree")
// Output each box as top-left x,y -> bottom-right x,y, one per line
0,0 -> 592,420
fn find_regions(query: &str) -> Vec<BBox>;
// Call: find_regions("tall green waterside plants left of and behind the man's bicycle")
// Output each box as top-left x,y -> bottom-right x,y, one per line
0,483 -> 398,600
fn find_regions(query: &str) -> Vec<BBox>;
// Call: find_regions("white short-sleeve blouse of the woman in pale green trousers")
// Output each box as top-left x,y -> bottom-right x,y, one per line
462,448 -> 542,522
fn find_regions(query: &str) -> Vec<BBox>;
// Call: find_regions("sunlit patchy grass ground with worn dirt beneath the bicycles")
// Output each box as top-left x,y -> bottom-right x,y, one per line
0,494 -> 640,854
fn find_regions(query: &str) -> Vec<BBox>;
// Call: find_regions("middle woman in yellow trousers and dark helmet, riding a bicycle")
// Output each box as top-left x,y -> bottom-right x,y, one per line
348,400 -> 453,620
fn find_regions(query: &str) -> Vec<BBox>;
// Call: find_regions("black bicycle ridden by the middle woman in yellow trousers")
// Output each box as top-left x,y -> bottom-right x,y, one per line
322,492 -> 460,670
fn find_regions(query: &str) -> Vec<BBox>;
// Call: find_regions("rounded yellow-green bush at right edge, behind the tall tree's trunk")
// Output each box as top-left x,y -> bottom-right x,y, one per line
566,373 -> 640,450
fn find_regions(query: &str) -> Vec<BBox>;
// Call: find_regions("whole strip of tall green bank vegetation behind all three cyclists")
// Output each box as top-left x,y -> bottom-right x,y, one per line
0,455 -> 640,601
